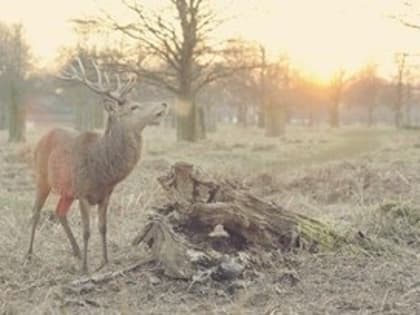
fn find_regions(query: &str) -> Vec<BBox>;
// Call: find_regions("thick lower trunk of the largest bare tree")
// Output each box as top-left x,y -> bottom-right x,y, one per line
176,93 -> 206,142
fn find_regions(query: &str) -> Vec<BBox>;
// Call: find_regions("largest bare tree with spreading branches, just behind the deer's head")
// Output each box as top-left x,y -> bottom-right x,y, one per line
76,0 -> 243,141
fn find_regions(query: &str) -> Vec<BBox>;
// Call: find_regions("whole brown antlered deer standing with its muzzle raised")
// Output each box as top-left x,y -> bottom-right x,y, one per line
27,58 -> 167,274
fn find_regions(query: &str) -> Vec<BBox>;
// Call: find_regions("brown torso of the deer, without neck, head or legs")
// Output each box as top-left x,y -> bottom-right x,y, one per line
35,127 -> 142,209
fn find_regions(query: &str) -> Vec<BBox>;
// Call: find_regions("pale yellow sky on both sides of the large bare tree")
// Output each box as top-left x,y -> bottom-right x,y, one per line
0,0 -> 420,80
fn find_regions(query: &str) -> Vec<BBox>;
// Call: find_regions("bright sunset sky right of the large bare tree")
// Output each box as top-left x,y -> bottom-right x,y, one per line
226,0 -> 420,80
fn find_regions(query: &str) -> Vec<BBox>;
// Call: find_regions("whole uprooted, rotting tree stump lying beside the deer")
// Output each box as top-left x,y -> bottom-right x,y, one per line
133,162 -> 346,279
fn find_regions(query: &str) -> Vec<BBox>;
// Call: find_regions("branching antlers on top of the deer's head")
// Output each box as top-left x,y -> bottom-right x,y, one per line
59,57 -> 137,105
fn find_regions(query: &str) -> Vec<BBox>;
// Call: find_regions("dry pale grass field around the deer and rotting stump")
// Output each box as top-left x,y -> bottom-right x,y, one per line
0,127 -> 420,315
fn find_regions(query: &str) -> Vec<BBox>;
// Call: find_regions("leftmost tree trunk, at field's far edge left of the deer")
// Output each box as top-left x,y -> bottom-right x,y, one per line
8,82 -> 26,142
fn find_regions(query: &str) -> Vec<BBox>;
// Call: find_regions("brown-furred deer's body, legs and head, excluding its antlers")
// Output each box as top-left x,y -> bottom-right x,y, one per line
28,103 -> 166,272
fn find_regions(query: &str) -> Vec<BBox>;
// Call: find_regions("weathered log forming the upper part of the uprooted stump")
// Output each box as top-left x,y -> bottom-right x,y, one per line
159,162 -> 344,250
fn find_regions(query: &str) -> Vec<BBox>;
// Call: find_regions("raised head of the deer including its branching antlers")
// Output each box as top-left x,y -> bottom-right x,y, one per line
59,58 -> 167,131
